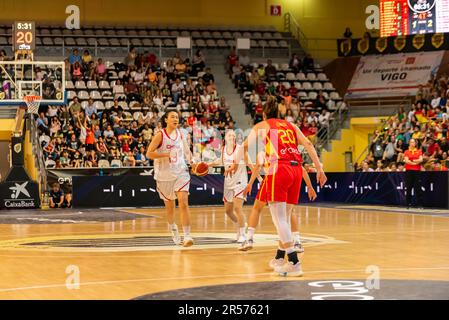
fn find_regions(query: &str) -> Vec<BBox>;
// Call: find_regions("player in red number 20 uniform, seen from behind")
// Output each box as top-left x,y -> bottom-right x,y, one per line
226,100 -> 327,276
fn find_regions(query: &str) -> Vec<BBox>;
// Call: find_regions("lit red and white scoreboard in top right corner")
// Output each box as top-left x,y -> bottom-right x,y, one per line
380,0 -> 449,37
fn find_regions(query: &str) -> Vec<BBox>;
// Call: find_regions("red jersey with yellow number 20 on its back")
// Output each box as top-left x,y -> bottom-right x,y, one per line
265,119 -> 302,164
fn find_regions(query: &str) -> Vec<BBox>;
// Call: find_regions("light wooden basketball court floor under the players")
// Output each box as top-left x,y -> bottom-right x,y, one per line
0,206 -> 449,299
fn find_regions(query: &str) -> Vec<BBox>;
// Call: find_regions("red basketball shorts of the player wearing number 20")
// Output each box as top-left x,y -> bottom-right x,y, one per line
256,161 -> 302,205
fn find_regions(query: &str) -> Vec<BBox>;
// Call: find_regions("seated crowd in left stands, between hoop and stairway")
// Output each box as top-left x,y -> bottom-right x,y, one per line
36,49 -> 235,168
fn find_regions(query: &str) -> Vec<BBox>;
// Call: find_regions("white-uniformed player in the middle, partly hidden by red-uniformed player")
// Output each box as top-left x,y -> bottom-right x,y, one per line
208,130 -> 248,243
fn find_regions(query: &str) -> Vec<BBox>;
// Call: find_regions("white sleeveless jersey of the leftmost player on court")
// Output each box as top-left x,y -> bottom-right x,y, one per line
154,129 -> 189,181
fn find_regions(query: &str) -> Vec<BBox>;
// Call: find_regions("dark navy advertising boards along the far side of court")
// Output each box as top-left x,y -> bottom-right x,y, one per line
73,172 -> 449,209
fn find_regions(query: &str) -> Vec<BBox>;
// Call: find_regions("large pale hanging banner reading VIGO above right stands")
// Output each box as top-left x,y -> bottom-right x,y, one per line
345,51 -> 443,99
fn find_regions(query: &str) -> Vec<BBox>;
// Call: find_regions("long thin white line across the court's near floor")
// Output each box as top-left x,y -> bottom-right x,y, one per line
0,266 -> 449,292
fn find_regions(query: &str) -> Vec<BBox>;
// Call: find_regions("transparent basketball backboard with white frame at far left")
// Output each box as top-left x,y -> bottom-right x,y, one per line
0,60 -> 66,106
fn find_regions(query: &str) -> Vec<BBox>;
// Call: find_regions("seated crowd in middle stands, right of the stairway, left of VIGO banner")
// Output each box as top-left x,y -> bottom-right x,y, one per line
227,51 -> 331,140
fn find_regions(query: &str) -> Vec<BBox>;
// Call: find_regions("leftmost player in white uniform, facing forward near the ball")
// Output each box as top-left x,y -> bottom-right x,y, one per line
147,111 -> 193,247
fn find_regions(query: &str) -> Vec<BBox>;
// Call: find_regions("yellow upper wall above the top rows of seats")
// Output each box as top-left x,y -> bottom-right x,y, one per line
0,0 -> 378,58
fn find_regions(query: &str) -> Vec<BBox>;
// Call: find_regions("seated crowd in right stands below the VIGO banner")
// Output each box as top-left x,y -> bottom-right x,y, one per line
355,76 -> 449,172
